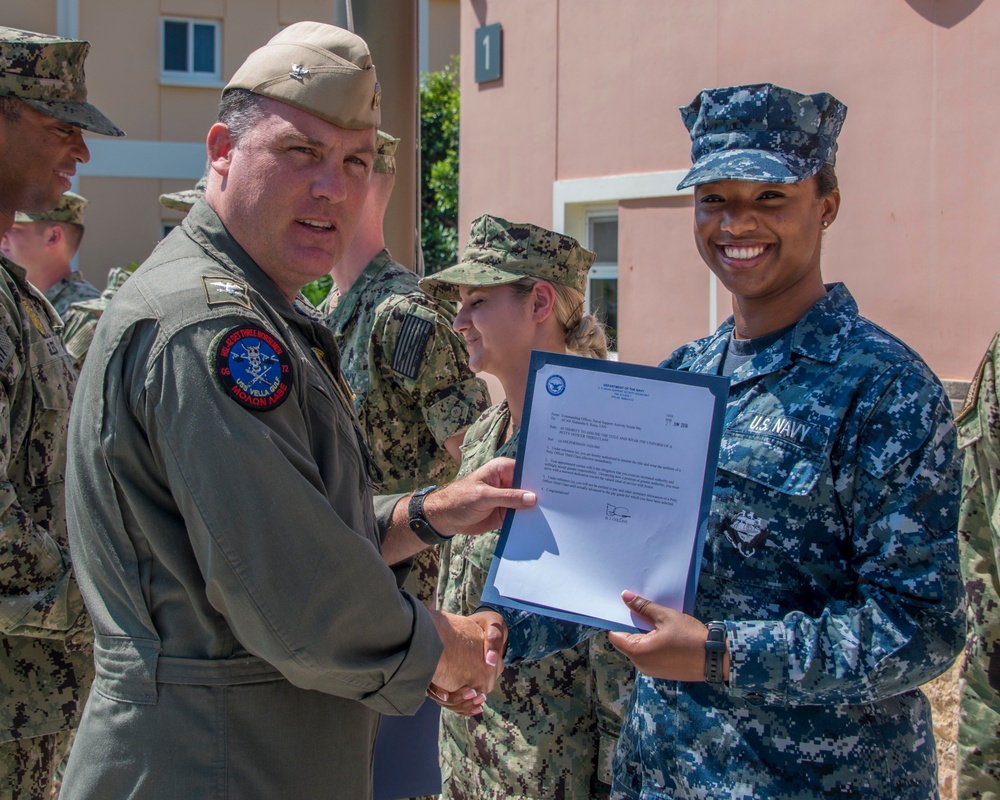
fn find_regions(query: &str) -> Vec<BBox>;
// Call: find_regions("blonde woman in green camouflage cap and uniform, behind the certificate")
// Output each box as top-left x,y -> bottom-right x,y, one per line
421,215 -> 633,800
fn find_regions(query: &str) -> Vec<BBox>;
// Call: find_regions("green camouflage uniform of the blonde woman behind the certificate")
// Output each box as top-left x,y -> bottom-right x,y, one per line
439,402 -> 634,800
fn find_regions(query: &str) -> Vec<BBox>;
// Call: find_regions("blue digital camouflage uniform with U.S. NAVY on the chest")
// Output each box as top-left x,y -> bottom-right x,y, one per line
496,285 -> 965,800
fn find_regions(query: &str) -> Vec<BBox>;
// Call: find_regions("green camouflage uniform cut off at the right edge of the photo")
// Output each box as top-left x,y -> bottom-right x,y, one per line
957,334 -> 1000,800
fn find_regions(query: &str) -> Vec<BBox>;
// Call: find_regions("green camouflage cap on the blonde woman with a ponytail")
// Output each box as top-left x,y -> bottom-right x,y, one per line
420,214 -> 595,300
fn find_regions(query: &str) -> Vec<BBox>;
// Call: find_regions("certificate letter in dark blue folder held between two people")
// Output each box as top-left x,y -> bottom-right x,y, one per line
482,351 -> 729,631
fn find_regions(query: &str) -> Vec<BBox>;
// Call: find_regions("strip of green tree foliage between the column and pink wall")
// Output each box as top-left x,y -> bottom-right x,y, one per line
420,56 -> 459,275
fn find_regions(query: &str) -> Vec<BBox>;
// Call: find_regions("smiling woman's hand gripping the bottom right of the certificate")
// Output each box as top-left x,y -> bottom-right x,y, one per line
608,592 -> 729,682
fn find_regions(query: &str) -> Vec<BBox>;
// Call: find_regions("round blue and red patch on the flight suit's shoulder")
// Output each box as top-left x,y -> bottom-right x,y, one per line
210,325 -> 292,411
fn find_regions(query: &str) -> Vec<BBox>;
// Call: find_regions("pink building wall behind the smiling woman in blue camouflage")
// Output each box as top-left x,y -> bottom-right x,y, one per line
460,0 -> 1000,379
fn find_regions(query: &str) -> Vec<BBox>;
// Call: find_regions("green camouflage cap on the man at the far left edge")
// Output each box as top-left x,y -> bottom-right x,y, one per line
0,27 -> 125,136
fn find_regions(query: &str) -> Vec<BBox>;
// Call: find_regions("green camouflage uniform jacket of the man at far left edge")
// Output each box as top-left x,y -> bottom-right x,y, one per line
0,258 -> 93,780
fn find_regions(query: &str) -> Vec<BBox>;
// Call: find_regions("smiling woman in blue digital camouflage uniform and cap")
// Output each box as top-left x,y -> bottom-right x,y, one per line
478,84 -> 965,800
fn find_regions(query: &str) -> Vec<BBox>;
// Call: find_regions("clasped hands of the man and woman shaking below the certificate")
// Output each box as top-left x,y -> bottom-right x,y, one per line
427,611 -> 507,716
